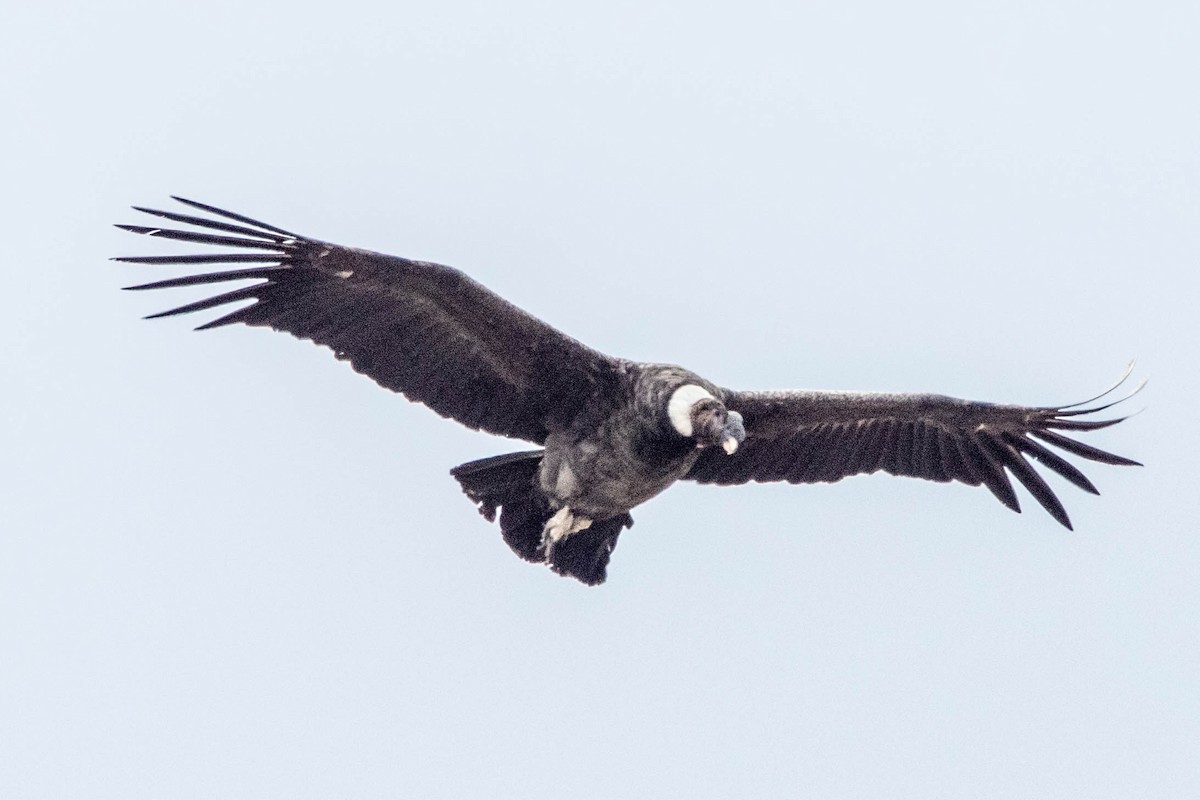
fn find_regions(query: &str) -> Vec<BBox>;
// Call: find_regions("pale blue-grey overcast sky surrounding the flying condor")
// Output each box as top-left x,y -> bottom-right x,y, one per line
0,0 -> 1200,800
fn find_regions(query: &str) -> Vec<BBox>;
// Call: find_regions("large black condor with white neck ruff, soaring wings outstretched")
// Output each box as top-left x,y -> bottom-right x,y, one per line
114,198 -> 1138,584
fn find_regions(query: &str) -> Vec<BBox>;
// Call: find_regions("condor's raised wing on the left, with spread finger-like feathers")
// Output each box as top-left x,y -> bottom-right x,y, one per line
114,198 -> 618,444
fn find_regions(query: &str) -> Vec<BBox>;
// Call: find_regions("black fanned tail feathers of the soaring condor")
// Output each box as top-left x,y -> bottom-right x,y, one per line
450,450 -> 634,585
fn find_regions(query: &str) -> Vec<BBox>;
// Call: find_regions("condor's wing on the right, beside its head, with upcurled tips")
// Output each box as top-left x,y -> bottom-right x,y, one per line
686,365 -> 1145,528
